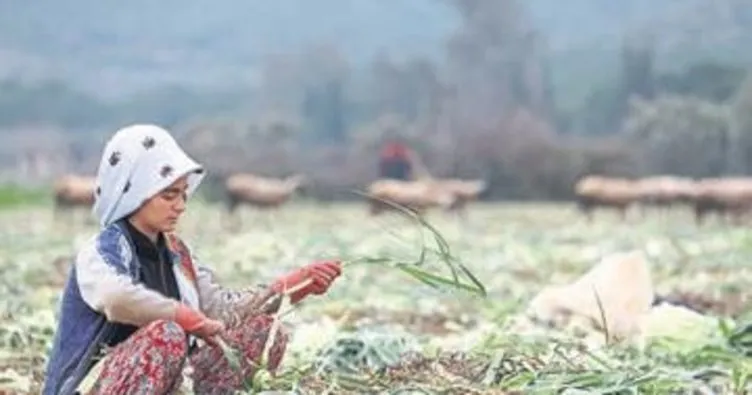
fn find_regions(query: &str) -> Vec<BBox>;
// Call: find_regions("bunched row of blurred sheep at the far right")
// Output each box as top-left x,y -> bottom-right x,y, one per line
574,175 -> 752,224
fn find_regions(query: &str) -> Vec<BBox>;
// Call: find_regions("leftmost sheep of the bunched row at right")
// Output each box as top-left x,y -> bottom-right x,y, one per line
574,176 -> 638,220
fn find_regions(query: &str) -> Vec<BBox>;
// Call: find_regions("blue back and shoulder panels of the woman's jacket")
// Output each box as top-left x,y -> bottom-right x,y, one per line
42,221 -> 188,395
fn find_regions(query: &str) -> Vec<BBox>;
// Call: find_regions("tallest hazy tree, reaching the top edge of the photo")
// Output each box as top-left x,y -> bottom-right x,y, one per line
440,0 -> 548,123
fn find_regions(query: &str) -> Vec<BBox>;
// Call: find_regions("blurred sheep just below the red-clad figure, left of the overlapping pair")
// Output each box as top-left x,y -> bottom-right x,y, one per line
367,179 -> 457,215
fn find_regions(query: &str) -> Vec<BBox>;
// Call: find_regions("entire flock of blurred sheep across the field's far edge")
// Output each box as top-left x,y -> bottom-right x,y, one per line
54,173 -> 752,224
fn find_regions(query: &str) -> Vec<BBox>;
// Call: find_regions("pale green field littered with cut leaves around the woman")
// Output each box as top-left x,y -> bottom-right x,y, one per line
0,203 -> 752,394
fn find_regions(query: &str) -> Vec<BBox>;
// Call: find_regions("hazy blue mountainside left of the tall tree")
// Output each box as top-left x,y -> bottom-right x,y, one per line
0,0 -> 453,96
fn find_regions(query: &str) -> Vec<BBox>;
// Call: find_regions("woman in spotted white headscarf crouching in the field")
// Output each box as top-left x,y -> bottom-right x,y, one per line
43,125 -> 340,394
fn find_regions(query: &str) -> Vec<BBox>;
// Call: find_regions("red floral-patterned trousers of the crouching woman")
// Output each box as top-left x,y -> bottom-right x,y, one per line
86,315 -> 289,394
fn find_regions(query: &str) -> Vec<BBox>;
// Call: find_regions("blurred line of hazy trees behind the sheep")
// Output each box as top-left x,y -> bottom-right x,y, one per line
0,0 -> 752,199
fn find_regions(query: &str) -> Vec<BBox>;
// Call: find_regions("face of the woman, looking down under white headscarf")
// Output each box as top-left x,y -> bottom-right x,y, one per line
133,176 -> 188,233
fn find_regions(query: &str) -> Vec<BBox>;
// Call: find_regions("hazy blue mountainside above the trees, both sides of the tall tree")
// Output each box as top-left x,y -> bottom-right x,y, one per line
0,0 -> 750,94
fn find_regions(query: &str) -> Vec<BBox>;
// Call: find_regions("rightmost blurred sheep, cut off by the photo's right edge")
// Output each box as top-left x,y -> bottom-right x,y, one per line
693,177 -> 752,225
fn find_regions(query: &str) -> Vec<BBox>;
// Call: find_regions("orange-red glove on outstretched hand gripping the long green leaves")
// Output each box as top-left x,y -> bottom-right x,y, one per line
272,261 -> 342,304
